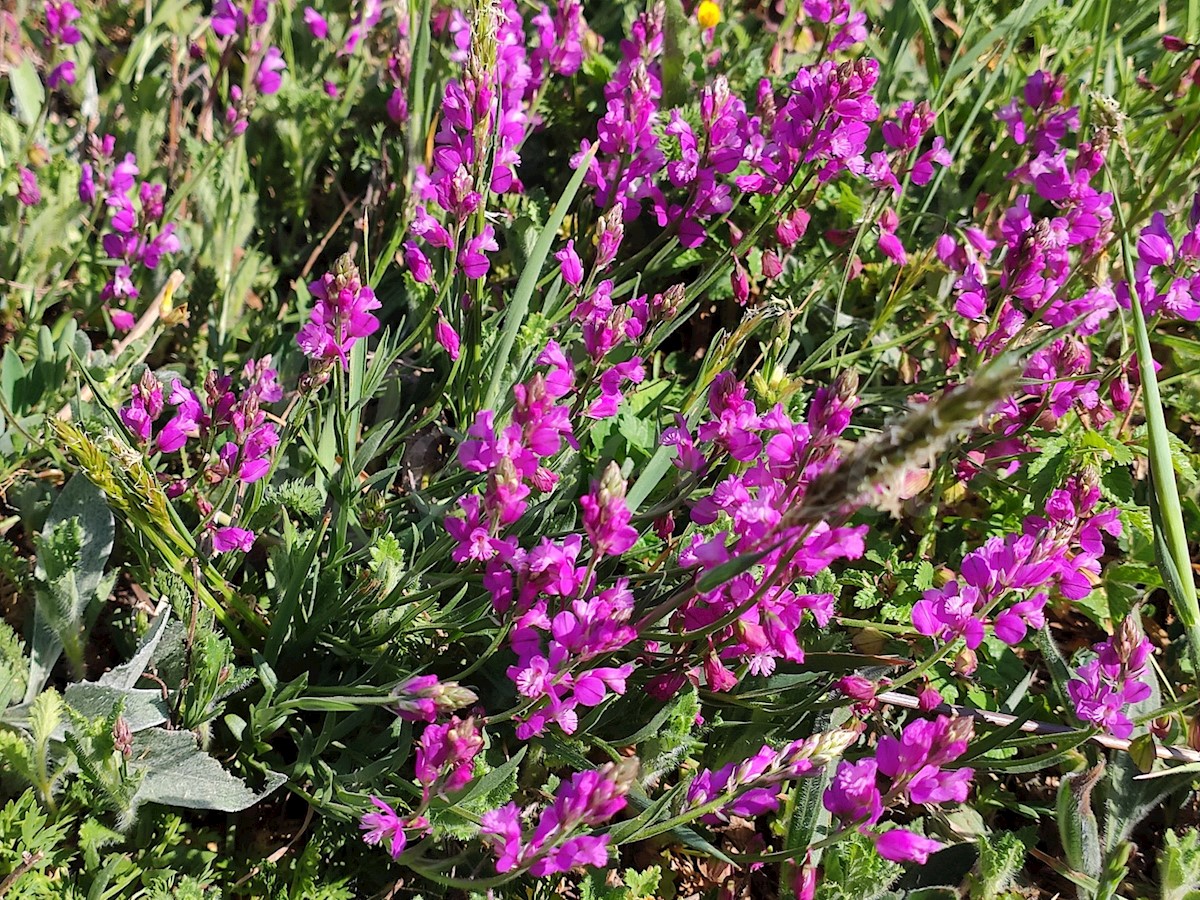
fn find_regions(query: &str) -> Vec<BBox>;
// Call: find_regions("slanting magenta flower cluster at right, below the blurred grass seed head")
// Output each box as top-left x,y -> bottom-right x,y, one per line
912,470 -> 1121,649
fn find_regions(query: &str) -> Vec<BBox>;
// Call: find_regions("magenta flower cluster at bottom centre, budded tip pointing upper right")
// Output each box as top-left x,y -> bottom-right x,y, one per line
480,760 -> 637,877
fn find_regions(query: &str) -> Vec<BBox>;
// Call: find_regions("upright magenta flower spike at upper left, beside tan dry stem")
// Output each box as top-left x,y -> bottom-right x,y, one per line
79,134 -> 180,331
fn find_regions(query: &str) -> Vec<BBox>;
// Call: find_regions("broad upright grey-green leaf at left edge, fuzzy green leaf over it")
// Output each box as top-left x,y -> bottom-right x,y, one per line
25,475 -> 115,703
